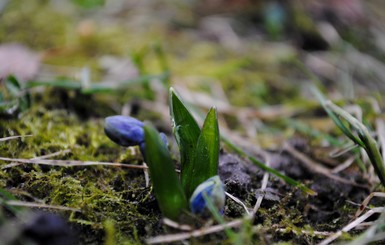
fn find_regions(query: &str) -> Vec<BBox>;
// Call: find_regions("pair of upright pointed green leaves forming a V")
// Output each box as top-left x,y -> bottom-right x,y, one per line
170,88 -> 220,197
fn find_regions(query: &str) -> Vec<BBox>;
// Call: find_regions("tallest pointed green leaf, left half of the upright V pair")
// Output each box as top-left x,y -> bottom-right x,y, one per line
170,88 -> 202,193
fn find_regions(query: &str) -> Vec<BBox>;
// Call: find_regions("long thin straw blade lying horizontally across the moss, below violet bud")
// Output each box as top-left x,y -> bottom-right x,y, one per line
0,157 -> 147,169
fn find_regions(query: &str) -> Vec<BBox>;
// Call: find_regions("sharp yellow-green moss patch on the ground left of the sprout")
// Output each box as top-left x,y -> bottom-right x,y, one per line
0,104 -> 160,241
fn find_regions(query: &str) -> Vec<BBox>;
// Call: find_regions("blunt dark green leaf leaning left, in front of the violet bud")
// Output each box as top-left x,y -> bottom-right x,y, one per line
144,123 -> 187,220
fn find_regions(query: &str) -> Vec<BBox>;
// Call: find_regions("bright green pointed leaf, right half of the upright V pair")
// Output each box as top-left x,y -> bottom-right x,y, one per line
185,107 -> 219,197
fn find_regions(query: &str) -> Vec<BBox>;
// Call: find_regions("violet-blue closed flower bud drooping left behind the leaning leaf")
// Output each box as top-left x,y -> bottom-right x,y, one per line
104,115 -> 168,156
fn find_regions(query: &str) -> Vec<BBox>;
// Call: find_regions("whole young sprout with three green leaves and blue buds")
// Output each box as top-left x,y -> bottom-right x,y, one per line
104,88 -> 225,220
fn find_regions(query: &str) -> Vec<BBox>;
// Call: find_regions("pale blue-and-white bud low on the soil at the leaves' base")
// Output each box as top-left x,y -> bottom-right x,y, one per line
190,175 -> 226,215
